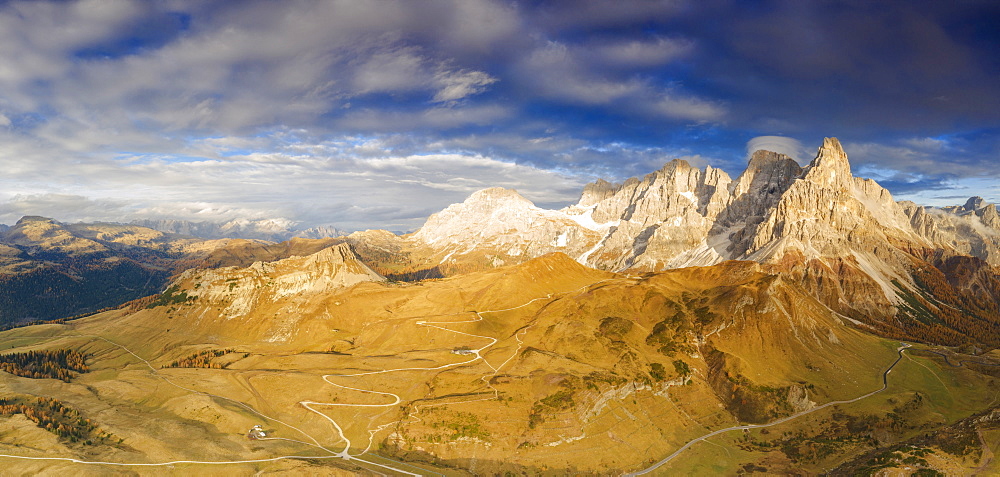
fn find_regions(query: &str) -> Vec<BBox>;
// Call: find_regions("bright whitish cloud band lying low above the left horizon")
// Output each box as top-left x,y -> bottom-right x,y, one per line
0,129 -> 584,230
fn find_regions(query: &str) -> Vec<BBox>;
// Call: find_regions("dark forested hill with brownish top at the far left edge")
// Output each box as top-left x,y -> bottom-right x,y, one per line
0,217 -> 184,324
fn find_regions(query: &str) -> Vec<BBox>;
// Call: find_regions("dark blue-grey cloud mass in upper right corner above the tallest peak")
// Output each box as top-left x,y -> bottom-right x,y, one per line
678,1 -> 1000,133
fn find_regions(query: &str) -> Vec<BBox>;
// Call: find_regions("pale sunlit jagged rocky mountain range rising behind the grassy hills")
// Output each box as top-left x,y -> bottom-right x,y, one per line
412,138 -> 1000,270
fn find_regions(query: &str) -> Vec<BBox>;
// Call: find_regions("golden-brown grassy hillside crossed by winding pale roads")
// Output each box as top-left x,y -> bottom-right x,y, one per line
0,254 -> 995,475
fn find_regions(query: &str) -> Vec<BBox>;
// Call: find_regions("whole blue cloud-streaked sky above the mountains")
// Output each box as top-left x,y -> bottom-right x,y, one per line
0,0 -> 1000,231
